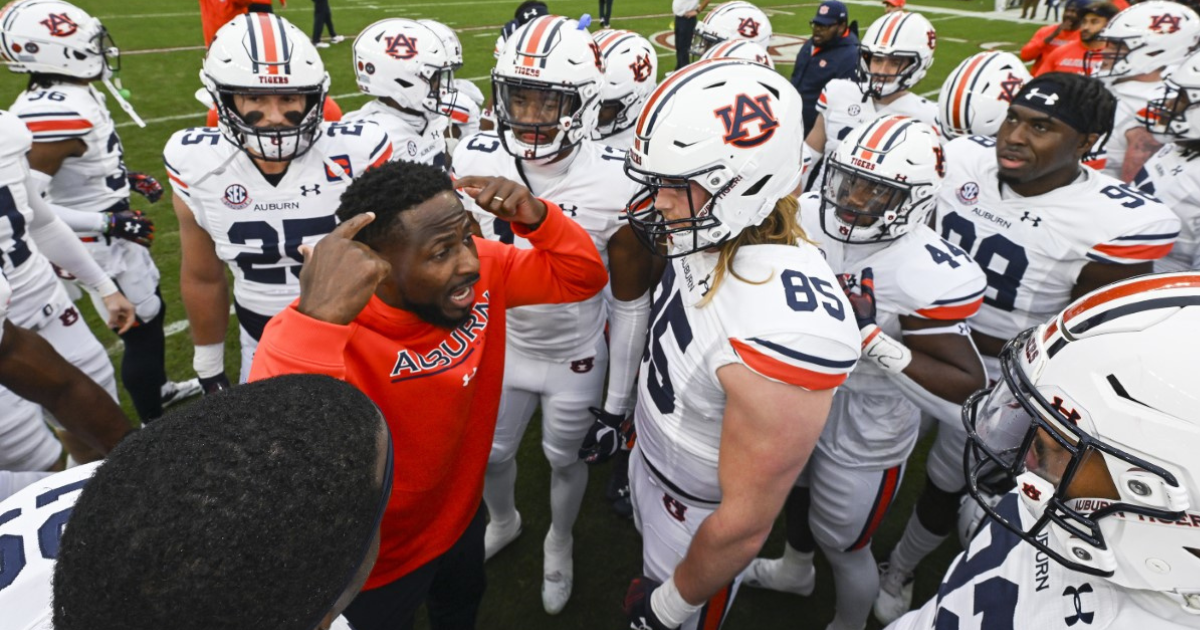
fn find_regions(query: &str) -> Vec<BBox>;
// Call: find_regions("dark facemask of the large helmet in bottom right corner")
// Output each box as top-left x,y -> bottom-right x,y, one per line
962,329 -> 1186,577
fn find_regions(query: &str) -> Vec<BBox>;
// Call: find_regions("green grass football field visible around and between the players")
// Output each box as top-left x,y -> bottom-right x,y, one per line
0,0 -> 1060,630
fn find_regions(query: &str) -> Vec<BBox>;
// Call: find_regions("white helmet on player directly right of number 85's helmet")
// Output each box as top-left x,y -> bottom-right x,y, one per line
821,115 -> 946,242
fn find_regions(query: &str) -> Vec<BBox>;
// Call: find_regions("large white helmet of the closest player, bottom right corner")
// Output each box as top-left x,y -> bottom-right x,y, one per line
962,271 -> 1200,614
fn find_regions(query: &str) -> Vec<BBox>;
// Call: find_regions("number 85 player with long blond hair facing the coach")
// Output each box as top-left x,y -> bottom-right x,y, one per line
625,60 -> 862,630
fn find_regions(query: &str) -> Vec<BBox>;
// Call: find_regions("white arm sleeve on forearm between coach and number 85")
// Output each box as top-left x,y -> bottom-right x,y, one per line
604,292 -> 650,416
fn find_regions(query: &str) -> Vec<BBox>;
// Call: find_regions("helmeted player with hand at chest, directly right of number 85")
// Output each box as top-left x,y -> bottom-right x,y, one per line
745,115 -> 986,630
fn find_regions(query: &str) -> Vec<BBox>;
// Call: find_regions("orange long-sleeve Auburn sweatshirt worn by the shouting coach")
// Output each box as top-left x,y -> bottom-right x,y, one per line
250,202 -> 608,589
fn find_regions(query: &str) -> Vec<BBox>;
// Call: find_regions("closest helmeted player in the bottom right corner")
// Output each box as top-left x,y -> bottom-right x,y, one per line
888,272 -> 1200,630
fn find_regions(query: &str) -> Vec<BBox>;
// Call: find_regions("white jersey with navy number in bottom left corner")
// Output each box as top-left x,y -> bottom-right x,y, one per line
0,461 -> 103,630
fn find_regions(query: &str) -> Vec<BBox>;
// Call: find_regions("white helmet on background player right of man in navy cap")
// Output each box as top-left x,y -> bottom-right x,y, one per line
858,11 -> 937,98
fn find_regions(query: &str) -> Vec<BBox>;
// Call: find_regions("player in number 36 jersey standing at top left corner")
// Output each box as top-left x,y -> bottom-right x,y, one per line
0,0 -> 199,421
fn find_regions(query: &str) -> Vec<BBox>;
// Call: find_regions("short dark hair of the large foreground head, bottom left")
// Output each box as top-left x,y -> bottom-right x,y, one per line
54,374 -> 383,630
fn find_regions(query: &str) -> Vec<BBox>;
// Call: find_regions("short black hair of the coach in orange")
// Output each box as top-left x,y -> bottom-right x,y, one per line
337,162 -> 454,250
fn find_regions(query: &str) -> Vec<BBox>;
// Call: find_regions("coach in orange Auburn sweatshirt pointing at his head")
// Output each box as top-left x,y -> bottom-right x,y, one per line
250,162 -> 608,630
